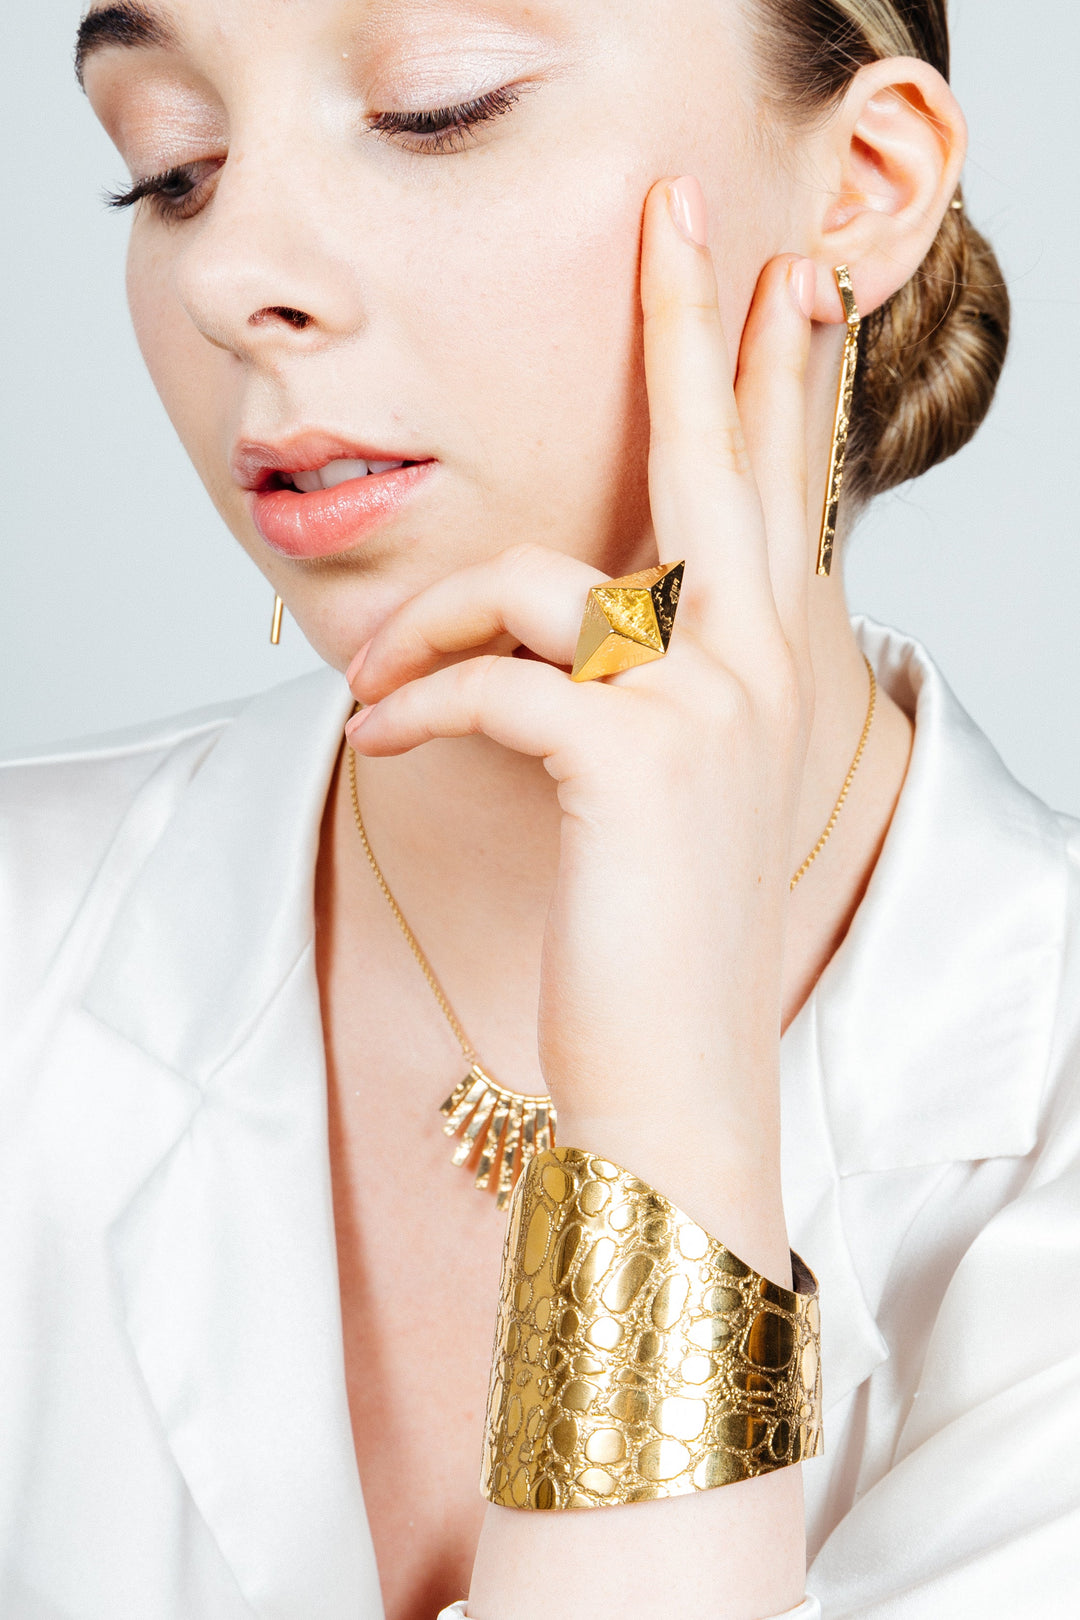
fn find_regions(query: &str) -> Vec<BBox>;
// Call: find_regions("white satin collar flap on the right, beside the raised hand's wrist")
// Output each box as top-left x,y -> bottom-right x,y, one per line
816,620 -> 1067,1176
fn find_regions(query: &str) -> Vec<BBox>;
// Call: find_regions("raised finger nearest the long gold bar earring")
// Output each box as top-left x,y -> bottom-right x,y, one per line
735,254 -> 816,654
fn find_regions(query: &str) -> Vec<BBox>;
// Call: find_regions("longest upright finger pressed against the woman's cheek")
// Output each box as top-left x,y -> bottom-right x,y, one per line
641,178 -> 776,653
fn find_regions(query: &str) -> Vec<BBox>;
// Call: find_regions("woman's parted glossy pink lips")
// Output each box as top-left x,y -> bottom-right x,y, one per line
232,433 -> 437,557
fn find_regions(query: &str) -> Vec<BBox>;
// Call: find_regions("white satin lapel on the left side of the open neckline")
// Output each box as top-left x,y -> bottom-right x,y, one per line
84,672 -> 382,1620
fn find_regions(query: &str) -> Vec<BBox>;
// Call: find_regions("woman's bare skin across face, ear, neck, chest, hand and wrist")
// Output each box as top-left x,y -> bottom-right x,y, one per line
86,0 -> 965,1620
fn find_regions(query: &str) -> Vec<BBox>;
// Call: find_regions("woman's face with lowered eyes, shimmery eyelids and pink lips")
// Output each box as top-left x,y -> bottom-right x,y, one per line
86,0 -> 800,667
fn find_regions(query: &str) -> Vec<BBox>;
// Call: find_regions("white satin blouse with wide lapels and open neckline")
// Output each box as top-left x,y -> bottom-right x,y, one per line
0,622 -> 1080,1620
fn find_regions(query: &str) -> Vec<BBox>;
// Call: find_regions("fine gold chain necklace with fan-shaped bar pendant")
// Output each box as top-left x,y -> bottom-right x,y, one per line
347,658 -> 878,1209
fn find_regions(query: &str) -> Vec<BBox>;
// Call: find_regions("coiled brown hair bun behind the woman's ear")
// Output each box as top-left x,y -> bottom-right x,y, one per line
847,207 -> 1010,504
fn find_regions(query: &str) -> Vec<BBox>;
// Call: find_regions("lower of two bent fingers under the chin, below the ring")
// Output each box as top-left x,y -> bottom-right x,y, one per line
345,656 -> 608,779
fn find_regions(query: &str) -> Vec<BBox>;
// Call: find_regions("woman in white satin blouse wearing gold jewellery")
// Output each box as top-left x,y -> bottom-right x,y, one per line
2,0 -> 1077,1620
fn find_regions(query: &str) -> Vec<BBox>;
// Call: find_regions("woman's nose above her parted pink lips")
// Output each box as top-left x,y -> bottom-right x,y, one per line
175,152 -> 366,365
